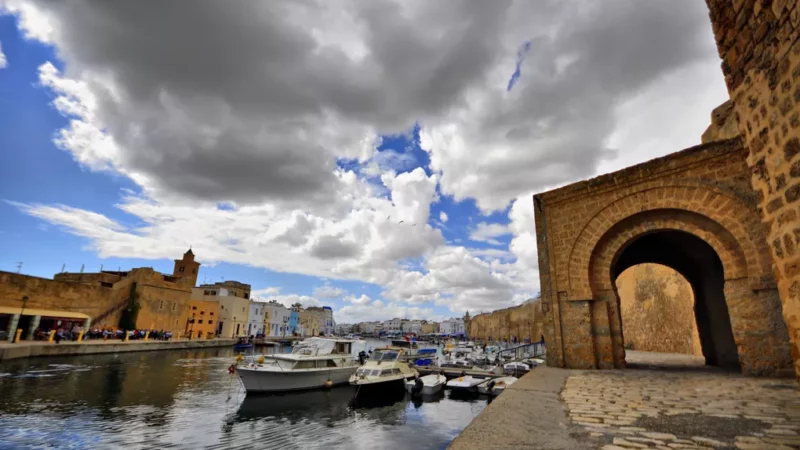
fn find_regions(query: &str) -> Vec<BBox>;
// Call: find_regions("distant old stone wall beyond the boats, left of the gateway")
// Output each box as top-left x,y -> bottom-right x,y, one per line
467,301 -> 544,341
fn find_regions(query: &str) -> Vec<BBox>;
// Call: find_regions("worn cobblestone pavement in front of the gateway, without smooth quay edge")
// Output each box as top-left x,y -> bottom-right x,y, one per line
561,369 -> 800,450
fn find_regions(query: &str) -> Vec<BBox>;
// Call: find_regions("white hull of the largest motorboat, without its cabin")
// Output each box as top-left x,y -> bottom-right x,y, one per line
236,366 -> 358,393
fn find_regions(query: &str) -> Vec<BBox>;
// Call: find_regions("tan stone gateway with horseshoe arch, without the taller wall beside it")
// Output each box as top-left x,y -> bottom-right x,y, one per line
534,139 -> 793,375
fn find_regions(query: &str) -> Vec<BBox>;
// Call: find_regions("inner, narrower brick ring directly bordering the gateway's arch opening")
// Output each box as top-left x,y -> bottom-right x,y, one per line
589,214 -> 747,292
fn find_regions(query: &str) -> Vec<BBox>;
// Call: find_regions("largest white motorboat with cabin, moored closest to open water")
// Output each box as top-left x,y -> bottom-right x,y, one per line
236,337 -> 367,392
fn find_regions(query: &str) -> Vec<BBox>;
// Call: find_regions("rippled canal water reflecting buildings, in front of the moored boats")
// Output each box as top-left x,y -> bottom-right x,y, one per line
0,342 -> 487,450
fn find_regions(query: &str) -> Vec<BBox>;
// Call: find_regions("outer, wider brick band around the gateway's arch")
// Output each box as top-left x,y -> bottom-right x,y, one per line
567,185 -> 772,298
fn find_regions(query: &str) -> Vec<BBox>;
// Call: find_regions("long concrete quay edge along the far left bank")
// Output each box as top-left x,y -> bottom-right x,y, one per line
0,339 -> 236,361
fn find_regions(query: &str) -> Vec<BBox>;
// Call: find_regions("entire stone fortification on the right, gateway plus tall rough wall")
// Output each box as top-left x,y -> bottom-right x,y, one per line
534,0 -> 800,375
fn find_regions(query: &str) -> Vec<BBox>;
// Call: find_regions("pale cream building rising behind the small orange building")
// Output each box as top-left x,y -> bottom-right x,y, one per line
192,280 -> 250,338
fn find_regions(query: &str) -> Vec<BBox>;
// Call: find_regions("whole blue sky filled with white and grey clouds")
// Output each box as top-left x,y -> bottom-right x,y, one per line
0,0 -> 727,323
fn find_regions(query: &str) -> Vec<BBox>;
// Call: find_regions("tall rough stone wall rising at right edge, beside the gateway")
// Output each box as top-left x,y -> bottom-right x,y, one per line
707,0 -> 800,376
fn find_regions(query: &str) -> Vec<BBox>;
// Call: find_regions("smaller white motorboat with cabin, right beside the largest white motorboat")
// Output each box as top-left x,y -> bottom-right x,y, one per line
350,347 -> 419,394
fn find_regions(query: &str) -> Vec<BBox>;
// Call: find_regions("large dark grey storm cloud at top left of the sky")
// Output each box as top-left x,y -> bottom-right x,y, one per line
23,0 -> 507,202
